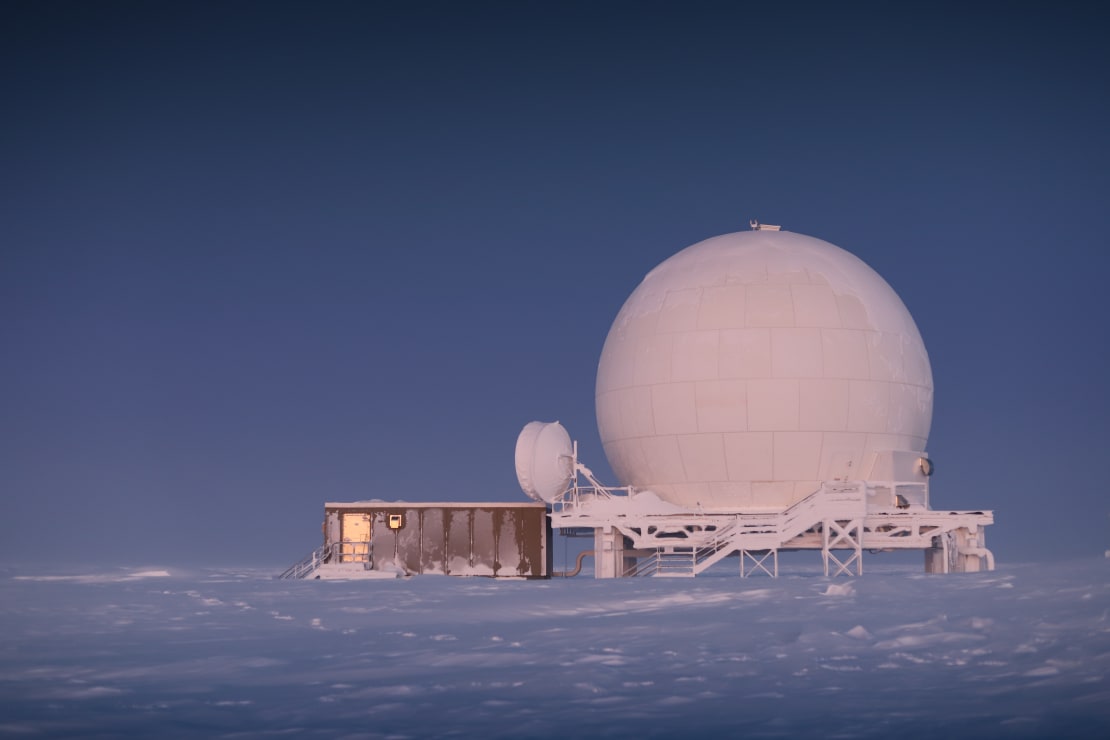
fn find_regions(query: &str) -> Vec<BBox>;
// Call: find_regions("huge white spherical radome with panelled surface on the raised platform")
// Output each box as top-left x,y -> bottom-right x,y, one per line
596,231 -> 932,510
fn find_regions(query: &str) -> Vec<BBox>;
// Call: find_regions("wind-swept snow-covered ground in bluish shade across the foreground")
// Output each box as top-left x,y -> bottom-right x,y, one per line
0,559 -> 1110,738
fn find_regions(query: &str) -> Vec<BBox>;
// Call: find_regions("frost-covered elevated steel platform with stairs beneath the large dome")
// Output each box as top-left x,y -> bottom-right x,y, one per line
548,480 -> 995,578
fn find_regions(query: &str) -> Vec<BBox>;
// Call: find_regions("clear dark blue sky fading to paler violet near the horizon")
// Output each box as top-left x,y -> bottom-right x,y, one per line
0,1 -> 1110,564
